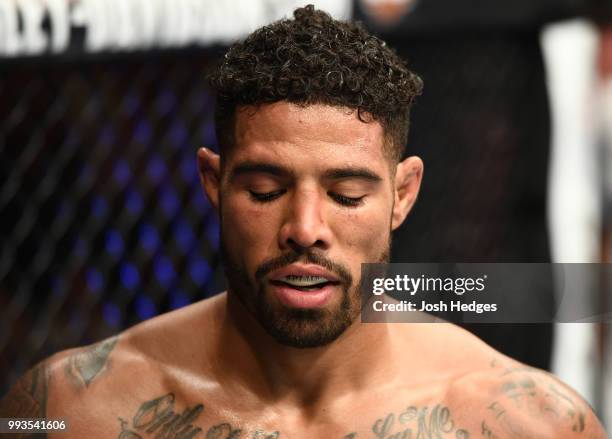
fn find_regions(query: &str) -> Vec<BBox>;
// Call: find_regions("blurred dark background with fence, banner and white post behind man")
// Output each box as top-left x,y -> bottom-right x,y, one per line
0,0 -> 612,426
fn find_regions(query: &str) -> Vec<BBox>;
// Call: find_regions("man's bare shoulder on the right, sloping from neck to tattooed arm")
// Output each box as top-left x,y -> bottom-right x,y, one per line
402,323 -> 607,439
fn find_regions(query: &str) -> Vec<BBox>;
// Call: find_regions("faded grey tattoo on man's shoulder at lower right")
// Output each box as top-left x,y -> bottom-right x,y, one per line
482,368 -> 587,439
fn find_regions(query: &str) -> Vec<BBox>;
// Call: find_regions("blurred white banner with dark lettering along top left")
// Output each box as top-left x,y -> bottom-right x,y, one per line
0,0 -> 351,56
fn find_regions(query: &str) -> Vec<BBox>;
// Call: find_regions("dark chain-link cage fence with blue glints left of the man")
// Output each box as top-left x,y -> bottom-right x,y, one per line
0,50 -> 230,394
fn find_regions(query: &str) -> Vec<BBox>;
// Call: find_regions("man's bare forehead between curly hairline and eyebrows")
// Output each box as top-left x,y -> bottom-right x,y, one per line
230,102 -> 388,171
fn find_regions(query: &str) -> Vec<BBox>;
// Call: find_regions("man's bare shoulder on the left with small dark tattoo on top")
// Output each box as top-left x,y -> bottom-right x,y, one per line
0,304 -> 220,438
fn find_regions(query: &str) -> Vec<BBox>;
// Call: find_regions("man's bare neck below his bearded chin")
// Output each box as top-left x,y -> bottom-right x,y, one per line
210,293 -> 398,407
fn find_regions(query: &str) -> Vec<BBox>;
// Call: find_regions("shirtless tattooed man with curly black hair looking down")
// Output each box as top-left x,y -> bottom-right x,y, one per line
0,7 -> 605,439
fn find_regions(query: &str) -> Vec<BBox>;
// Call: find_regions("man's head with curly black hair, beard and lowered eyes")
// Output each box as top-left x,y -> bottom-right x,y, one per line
199,6 -> 422,347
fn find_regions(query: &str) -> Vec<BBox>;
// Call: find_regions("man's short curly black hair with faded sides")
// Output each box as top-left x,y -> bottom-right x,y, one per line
210,5 -> 423,161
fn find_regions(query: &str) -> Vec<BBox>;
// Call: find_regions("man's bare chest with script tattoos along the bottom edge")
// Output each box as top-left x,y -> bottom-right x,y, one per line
62,391 -> 475,439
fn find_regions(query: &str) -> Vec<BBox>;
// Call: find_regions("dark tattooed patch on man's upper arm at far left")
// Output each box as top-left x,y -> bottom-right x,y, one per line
0,362 -> 50,439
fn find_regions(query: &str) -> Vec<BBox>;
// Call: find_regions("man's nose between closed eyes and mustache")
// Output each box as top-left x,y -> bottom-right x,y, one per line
279,189 -> 332,252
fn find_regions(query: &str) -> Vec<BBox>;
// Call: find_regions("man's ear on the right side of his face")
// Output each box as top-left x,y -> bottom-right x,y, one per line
391,156 -> 423,230
